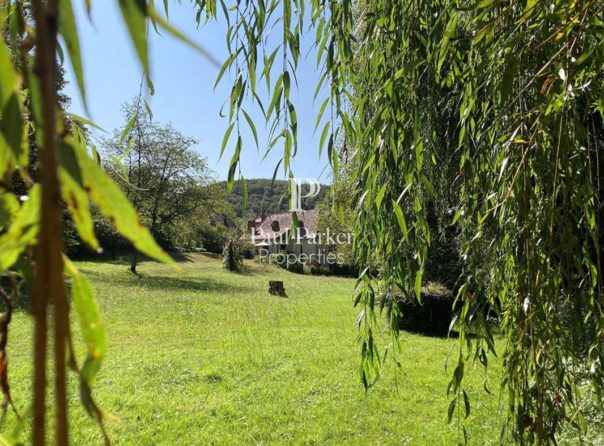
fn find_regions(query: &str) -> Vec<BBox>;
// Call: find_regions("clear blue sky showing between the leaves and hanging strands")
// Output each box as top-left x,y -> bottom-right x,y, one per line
65,1 -> 330,183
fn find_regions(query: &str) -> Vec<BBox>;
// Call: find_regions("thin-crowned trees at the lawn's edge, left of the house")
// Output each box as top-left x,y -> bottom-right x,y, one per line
65,98 -> 240,273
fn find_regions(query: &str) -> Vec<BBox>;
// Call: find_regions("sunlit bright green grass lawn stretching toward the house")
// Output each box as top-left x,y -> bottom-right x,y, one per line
8,255 -> 501,445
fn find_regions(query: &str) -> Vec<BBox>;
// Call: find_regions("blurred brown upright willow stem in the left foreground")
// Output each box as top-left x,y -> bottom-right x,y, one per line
33,0 -> 68,446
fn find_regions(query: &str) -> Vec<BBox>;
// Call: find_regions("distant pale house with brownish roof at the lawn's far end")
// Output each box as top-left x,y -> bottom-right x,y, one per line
247,210 -> 322,255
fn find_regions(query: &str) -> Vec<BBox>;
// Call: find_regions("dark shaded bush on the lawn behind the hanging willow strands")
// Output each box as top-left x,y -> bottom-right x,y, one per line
382,284 -> 455,336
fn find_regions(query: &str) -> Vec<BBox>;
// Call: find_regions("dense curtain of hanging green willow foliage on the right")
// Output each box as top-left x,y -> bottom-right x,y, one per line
190,0 -> 604,444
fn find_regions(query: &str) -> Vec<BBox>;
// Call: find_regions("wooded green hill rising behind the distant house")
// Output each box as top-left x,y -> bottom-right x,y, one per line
224,178 -> 329,217
